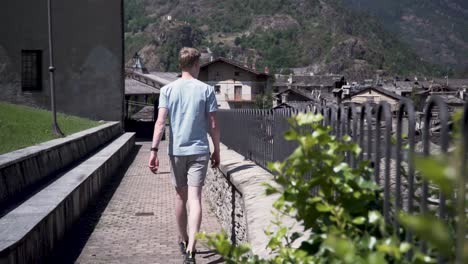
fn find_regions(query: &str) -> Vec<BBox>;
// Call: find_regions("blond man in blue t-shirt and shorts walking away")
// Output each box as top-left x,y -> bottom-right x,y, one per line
149,48 -> 219,263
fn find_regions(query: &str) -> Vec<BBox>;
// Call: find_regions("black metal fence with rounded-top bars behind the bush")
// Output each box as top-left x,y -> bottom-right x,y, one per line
218,96 -> 468,263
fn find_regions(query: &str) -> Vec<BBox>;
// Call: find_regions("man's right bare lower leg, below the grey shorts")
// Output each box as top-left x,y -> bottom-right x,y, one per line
187,186 -> 202,252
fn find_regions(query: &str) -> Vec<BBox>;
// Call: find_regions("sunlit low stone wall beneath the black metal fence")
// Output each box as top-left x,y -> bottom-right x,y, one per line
205,145 -> 302,258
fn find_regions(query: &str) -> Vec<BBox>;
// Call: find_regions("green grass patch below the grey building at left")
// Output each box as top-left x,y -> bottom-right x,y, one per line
0,102 -> 99,154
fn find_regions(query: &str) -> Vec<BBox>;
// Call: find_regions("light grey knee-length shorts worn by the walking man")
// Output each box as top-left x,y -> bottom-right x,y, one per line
169,154 -> 210,187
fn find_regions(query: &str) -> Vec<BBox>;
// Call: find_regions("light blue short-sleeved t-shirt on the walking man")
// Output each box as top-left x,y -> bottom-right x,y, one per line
159,79 -> 218,156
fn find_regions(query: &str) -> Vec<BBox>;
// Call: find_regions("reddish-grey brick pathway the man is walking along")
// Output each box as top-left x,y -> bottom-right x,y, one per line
76,141 -> 222,264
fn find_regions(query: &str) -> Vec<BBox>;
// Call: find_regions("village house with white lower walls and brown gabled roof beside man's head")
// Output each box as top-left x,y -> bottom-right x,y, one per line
199,58 -> 270,109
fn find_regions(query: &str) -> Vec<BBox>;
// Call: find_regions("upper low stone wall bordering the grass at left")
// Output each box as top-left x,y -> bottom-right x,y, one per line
0,122 -> 123,210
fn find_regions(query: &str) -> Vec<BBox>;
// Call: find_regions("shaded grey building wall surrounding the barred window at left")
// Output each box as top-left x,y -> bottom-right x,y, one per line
0,0 -> 124,120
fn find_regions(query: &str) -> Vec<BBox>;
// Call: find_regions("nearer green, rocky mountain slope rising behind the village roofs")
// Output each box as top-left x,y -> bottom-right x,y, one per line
126,0 -> 450,79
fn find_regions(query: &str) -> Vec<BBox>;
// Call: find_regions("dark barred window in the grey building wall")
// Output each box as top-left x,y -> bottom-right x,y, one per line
21,50 -> 42,91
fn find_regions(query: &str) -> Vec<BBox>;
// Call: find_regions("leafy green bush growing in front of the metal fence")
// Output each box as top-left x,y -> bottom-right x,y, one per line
201,113 -> 464,263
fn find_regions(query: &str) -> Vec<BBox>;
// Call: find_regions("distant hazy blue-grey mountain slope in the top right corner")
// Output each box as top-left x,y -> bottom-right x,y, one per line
343,0 -> 468,76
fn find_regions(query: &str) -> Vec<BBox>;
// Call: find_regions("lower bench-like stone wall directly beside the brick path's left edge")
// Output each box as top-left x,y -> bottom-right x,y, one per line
0,133 -> 135,263
